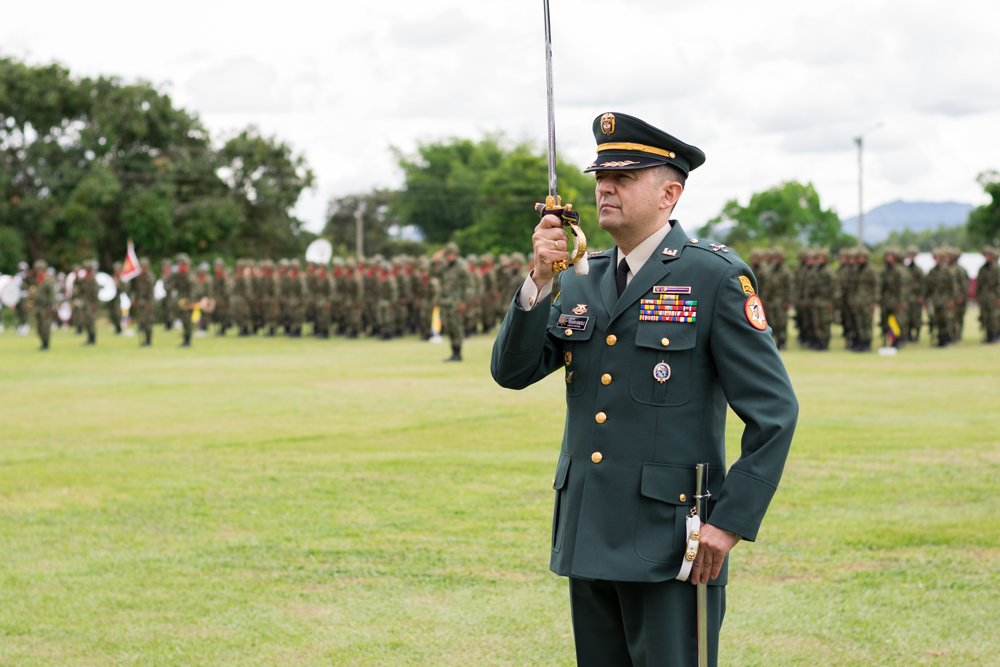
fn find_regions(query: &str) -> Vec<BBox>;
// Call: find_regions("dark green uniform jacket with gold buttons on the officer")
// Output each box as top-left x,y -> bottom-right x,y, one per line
491,222 -> 798,585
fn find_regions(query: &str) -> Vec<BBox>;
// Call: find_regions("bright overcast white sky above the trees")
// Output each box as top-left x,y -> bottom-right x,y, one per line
0,0 -> 1000,232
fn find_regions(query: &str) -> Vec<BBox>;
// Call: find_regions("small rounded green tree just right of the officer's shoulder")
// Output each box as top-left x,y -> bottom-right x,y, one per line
699,181 -> 847,246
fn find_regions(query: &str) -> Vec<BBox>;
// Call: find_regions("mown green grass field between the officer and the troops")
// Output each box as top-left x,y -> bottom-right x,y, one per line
0,320 -> 1000,667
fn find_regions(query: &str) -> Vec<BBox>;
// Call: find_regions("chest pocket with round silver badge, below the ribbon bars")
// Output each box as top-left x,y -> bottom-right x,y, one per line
629,322 -> 698,406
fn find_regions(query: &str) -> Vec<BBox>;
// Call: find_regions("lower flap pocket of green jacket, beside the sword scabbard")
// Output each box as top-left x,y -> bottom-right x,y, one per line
635,463 -> 695,563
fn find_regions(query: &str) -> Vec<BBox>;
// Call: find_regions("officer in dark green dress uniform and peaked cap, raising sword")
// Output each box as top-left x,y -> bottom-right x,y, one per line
491,113 -> 798,667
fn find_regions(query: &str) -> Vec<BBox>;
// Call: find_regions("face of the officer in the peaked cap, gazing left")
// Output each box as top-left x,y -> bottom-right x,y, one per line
595,169 -> 683,235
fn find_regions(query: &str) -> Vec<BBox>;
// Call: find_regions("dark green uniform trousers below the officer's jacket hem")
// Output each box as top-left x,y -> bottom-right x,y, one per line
569,577 -> 726,667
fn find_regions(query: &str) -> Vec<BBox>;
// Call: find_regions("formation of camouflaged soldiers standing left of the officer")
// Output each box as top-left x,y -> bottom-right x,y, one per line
5,243 -> 584,352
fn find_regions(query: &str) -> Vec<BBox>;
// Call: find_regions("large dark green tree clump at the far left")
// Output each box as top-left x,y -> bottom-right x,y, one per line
0,58 -> 313,269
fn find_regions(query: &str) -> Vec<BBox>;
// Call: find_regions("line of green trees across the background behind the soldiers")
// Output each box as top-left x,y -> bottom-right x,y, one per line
0,58 -> 1000,273
